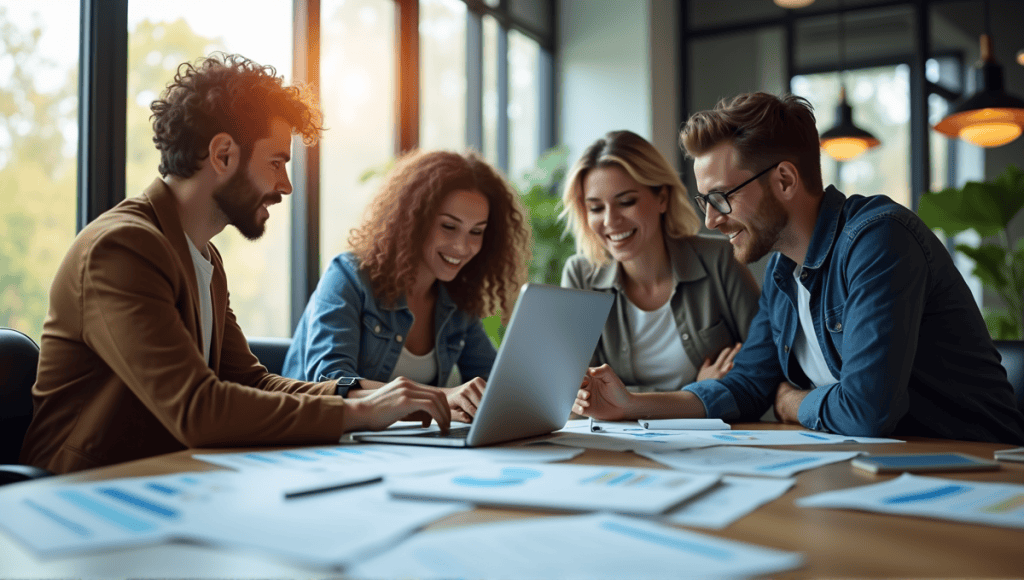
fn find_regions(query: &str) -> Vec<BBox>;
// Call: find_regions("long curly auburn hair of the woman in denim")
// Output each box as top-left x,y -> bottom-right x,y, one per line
348,151 -> 532,322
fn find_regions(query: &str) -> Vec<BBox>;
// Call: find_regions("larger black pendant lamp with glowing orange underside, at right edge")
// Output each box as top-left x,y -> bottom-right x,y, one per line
935,2 -> 1024,147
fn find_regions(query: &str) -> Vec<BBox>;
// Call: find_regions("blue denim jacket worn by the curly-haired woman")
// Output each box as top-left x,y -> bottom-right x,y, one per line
282,252 -> 496,386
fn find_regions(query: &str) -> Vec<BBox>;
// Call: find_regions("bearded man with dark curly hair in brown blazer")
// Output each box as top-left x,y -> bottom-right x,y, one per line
22,53 -> 451,473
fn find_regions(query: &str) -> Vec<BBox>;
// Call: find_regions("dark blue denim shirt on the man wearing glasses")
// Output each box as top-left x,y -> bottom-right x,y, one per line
686,187 -> 1024,445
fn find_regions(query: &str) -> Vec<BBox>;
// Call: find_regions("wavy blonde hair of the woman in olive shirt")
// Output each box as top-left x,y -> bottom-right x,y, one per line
559,131 -> 701,265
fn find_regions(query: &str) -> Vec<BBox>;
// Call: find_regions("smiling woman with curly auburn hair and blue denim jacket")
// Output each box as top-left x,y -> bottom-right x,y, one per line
283,151 -> 530,422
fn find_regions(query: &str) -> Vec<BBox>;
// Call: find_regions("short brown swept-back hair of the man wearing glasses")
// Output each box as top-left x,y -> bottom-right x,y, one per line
679,92 -> 824,193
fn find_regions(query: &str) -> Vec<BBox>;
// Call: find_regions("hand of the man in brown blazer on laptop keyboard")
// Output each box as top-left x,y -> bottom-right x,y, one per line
346,377 -> 452,432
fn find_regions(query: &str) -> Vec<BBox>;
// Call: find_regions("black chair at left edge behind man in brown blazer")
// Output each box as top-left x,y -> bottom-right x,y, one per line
0,328 -> 52,486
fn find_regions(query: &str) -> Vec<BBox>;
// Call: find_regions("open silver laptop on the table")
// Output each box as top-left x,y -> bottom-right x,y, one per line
351,284 -> 613,447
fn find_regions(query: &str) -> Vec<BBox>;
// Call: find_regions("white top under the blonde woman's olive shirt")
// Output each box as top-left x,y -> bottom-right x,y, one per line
624,295 -> 697,390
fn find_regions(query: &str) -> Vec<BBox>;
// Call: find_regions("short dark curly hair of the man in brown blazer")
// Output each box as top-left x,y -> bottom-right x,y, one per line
150,52 -> 324,177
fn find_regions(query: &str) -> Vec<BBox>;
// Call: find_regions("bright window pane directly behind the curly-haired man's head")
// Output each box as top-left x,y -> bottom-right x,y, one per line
125,0 -> 292,336
